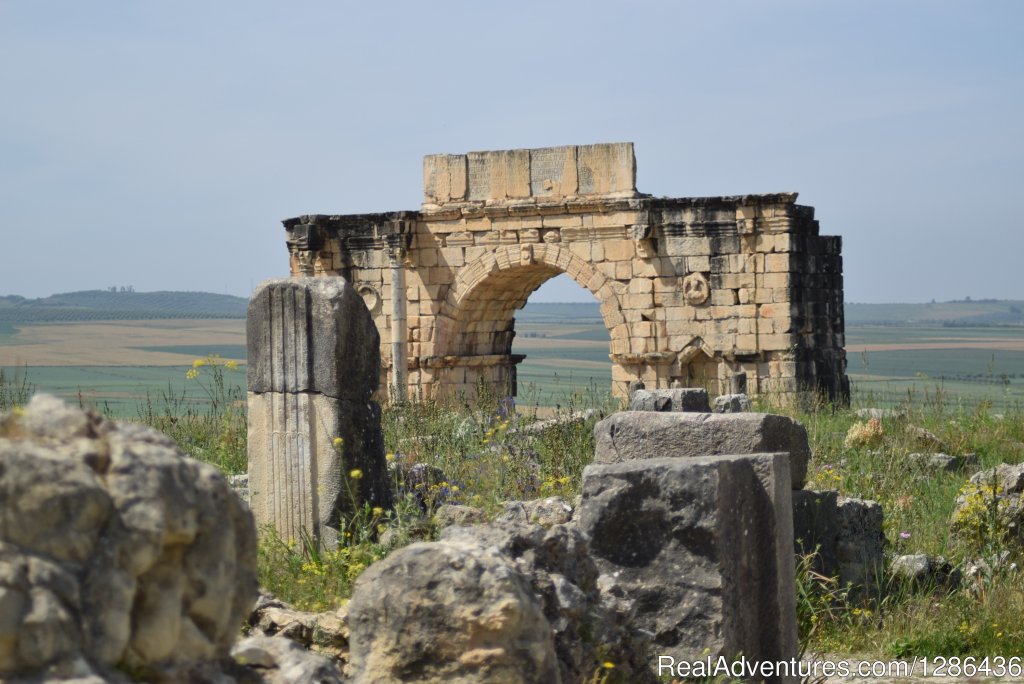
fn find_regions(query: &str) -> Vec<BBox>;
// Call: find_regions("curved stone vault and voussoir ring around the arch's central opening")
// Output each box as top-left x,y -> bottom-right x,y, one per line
434,243 -> 630,397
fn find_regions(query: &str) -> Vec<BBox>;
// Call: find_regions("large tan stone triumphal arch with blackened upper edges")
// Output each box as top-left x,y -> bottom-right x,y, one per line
284,143 -> 849,399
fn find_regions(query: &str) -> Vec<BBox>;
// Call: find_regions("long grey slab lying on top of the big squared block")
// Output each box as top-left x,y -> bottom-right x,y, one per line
594,411 -> 811,489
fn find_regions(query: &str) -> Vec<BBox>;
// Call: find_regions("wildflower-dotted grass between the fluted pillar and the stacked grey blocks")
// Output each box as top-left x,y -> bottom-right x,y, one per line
259,385 -> 617,610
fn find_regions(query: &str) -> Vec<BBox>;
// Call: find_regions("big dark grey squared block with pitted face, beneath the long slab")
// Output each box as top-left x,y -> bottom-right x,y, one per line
574,454 -> 797,660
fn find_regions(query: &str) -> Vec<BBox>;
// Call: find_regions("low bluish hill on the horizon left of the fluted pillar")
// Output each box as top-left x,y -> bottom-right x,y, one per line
0,290 -> 248,324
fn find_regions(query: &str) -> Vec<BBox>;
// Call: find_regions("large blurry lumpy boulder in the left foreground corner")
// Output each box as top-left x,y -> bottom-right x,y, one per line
0,394 -> 257,682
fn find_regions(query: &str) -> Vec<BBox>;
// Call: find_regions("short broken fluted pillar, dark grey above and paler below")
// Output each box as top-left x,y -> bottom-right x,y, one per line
247,277 -> 391,547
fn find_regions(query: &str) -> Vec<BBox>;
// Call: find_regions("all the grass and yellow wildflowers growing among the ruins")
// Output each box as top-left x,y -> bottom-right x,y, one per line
0,366 -> 1024,657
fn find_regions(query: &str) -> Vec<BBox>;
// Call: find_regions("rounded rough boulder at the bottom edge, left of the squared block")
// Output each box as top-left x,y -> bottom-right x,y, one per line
348,542 -> 560,684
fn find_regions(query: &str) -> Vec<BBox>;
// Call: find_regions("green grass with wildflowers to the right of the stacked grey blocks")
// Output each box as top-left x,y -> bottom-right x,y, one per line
775,389 -> 1024,657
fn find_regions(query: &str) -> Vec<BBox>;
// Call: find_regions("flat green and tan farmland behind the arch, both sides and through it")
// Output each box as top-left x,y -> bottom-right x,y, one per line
0,293 -> 1024,416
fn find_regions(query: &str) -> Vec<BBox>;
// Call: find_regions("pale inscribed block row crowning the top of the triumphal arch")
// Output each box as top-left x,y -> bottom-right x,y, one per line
423,142 -> 637,206
